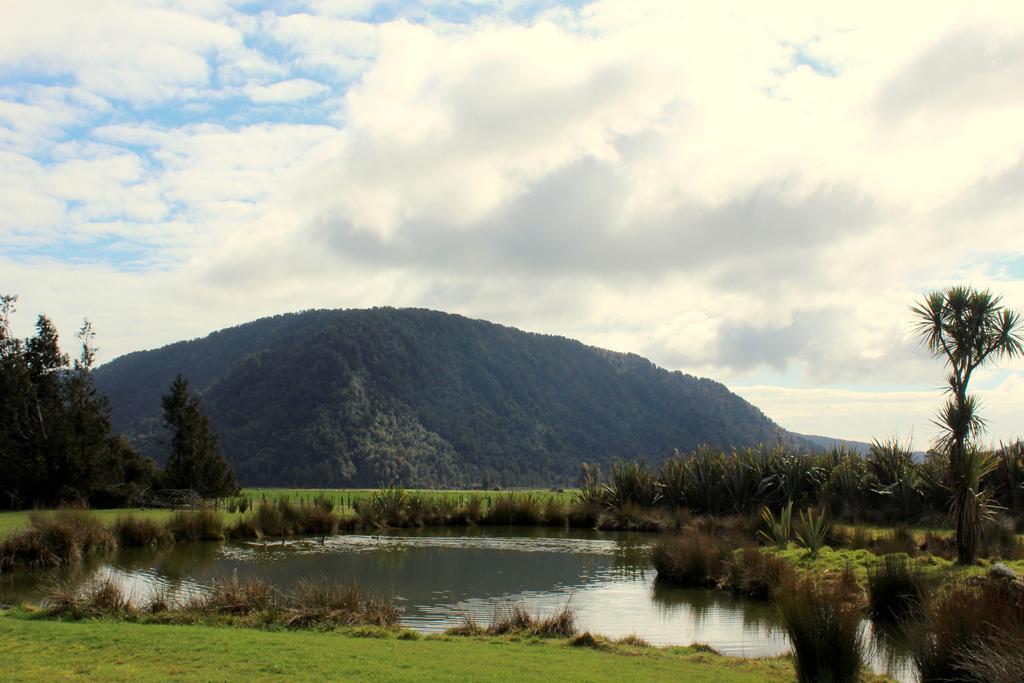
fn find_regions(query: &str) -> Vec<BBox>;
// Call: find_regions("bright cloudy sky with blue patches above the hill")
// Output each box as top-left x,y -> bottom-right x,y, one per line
0,0 -> 1024,449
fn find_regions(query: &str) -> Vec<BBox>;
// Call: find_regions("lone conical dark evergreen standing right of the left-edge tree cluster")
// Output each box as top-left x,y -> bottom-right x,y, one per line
163,373 -> 239,498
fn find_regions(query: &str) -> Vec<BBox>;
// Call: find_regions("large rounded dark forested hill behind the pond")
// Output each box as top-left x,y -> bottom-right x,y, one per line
95,308 -> 786,486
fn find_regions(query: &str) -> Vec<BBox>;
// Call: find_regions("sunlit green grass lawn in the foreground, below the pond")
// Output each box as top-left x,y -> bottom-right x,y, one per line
0,612 -> 794,683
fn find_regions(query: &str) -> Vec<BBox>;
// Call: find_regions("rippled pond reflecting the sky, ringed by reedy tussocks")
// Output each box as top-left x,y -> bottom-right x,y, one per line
0,527 -> 908,680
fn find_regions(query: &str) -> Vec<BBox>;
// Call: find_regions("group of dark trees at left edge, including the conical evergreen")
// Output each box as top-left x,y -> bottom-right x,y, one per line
0,295 -> 237,509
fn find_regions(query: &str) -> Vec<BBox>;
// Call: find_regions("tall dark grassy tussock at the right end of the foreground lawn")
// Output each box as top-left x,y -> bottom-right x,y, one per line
775,580 -> 864,683
